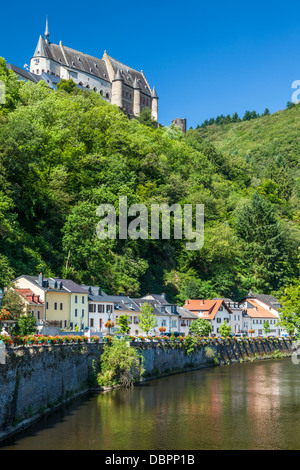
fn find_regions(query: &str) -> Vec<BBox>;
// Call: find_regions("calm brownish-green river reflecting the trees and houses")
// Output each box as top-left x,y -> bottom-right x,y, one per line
1,358 -> 300,450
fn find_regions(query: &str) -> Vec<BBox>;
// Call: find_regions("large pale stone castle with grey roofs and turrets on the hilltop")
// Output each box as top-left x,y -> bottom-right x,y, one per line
30,20 -> 158,122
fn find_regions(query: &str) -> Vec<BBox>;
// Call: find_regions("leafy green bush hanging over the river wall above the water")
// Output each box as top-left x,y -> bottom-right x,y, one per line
98,340 -> 144,388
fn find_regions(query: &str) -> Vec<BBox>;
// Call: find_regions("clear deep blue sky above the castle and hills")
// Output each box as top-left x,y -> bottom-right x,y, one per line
0,0 -> 300,127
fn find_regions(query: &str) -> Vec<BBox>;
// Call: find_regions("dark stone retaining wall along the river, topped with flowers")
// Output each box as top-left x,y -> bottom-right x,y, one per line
0,340 -> 292,440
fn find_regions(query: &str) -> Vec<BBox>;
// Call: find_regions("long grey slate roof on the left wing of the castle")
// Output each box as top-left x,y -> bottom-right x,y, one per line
34,36 -> 109,82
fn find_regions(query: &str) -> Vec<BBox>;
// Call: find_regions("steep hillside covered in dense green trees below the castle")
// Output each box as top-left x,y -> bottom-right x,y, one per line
0,59 -> 300,302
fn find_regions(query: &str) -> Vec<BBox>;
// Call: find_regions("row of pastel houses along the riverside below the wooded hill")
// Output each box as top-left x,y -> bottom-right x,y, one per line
9,273 -> 285,336
